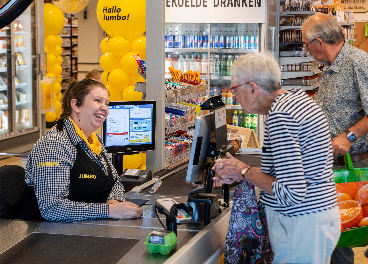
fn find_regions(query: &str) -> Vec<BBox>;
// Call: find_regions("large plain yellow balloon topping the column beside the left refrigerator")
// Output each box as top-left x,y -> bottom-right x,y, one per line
43,4 -> 65,35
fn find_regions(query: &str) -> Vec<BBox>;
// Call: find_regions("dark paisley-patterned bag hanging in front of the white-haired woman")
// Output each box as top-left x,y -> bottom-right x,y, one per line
224,181 -> 273,264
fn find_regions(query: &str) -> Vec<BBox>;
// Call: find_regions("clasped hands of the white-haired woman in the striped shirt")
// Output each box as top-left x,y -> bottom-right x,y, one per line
212,153 -> 250,184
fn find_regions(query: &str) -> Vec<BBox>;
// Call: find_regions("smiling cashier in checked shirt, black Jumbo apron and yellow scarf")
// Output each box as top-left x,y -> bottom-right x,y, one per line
17,79 -> 143,222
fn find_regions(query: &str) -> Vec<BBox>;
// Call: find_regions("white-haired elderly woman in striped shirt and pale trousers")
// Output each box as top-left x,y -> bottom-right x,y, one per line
213,54 -> 341,263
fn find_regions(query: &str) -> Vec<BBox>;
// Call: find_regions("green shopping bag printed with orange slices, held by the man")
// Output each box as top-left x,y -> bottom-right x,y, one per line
333,153 -> 368,248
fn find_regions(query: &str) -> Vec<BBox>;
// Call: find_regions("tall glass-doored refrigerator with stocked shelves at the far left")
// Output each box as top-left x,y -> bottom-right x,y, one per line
0,2 -> 43,150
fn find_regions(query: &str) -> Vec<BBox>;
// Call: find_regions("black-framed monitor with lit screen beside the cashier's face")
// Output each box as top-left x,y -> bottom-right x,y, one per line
102,100 -> 156,153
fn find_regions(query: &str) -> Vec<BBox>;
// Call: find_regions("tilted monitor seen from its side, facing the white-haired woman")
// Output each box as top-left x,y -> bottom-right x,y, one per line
186,103 -> 227,182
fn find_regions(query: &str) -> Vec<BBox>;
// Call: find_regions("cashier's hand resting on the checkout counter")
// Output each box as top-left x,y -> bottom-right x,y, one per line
107,200 -> 143,219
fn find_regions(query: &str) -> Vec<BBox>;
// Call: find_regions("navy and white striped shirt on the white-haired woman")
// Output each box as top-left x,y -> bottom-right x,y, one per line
261,89 -> 337,216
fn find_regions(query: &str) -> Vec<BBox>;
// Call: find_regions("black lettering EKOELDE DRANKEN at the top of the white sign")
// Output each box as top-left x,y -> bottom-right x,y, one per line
165,0 -> 261,7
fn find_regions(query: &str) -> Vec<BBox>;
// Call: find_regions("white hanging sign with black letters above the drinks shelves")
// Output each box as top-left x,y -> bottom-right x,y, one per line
164,0 -> 267,23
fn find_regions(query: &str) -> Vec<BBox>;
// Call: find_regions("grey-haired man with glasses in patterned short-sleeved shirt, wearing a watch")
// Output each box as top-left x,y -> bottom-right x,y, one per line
302,14 -> 368,264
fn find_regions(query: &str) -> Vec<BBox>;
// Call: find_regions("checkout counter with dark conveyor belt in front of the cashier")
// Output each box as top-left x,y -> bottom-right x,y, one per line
0,155 -> 260,264
